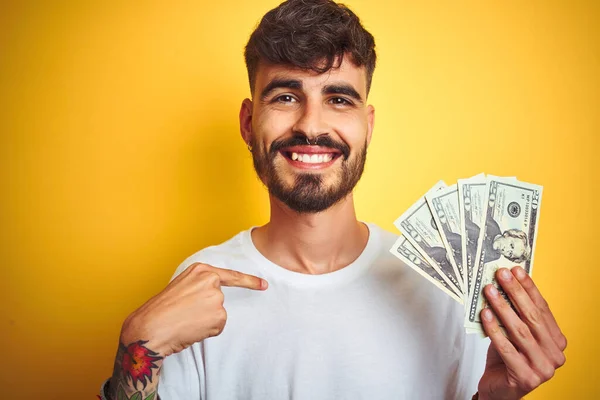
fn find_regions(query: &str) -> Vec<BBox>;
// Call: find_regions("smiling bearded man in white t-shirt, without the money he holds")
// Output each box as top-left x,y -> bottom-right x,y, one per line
103,0 -> 566,400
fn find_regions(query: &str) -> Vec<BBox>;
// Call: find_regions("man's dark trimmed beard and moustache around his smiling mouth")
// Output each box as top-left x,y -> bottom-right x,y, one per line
252,136 -> 367,214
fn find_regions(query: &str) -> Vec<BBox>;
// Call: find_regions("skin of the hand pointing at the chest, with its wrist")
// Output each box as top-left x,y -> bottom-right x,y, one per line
108,263 -> 268,399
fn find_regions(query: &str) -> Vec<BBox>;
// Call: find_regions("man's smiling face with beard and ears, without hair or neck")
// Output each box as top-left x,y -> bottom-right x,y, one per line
240,57 -> 374,213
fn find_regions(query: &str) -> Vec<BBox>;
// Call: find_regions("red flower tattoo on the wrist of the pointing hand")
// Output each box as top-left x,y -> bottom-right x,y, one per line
121,340 -> 162,388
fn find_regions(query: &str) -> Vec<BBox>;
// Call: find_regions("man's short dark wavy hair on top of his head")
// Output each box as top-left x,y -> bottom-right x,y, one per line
244,0 -> 376,93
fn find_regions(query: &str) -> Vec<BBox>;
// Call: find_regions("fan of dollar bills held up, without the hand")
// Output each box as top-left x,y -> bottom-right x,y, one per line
390,174 -> 542,333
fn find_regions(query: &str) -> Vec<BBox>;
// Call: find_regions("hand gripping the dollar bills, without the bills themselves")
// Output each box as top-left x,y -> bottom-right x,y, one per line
478,267 -> 567,400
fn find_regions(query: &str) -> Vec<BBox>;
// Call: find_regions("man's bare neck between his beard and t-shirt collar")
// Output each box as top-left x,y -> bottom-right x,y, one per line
252,194 -> 369,274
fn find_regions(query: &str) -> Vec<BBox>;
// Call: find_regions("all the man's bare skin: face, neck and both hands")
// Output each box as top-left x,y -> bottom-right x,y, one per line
109,57 -> 566,400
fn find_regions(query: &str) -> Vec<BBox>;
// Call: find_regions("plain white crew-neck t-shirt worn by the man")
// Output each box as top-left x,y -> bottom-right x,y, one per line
158,224 -> 489,400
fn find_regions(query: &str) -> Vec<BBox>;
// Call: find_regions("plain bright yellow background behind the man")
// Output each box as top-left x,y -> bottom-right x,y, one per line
0,0 -> 600,399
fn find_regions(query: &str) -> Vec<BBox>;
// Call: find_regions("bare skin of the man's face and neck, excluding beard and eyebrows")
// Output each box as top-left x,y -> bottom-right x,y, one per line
240,57 -> 375,274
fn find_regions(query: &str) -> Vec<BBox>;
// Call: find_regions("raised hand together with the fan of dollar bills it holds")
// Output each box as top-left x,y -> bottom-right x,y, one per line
390,174 -> 566,399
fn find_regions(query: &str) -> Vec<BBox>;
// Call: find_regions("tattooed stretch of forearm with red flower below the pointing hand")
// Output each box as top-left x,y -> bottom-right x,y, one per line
109,340 -> 163,400
